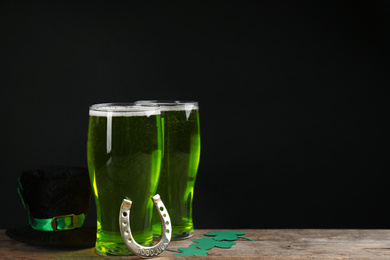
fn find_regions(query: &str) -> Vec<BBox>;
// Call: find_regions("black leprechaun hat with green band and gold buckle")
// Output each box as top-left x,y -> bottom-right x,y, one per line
6,166 -> 96,248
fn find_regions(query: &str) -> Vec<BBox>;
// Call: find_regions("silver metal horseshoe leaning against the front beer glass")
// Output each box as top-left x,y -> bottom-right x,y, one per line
119,194 -> 172,258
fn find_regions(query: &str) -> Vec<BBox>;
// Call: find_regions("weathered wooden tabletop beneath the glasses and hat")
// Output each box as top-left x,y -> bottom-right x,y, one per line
0,229 -> 390,260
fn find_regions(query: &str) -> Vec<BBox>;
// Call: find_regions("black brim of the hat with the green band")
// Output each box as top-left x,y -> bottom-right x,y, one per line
6,226 -> 96,248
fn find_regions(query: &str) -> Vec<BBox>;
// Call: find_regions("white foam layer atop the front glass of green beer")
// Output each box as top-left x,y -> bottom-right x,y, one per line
89,106 -> 161,117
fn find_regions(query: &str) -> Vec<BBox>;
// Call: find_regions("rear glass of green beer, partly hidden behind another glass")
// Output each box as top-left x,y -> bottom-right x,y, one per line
135,100 -> 200,240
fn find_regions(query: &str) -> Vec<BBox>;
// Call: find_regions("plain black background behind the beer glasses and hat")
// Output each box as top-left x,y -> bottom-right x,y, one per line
0,0 -> 390,229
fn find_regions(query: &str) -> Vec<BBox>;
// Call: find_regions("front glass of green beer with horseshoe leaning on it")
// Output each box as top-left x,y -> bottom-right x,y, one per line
87,103 -> 162,255
